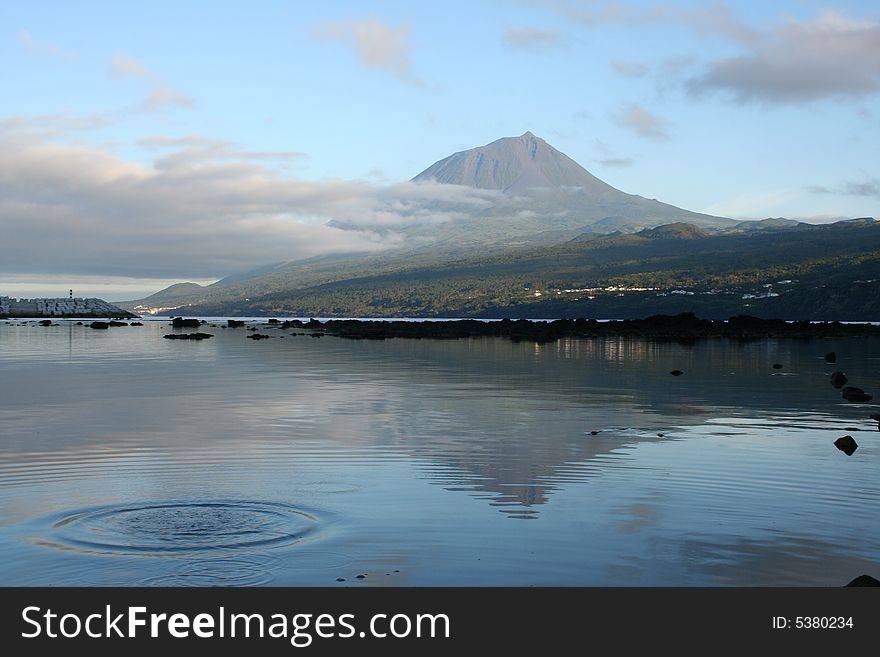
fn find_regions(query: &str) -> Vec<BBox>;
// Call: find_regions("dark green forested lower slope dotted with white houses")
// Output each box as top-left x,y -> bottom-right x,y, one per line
144,221 -> 880,320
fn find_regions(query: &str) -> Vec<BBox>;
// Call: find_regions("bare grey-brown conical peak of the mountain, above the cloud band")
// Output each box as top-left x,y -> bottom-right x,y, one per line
412,132 -> 616,195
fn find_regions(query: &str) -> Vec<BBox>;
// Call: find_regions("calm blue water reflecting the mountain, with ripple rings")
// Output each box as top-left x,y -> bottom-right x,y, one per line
0,322 -> 880,586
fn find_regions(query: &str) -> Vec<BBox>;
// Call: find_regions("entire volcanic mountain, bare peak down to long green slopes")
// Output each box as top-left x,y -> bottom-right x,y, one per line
120,132 -> 880,317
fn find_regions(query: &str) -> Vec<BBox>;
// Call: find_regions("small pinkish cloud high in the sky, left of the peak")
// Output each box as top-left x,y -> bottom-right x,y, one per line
314,19 -> 422,86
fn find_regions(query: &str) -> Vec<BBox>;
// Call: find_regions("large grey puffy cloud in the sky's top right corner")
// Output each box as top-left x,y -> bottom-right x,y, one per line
688,10 -> 880,103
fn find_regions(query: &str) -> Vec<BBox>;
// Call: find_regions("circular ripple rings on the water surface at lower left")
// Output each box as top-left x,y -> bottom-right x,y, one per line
37,500 -> 318,556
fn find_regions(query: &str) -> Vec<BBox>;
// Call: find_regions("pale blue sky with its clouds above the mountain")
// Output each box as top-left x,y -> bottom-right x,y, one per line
0,0 -> 880,298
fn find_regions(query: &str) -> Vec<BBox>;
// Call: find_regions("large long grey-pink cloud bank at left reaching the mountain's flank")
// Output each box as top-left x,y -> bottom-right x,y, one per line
0,131 -> 493,279
